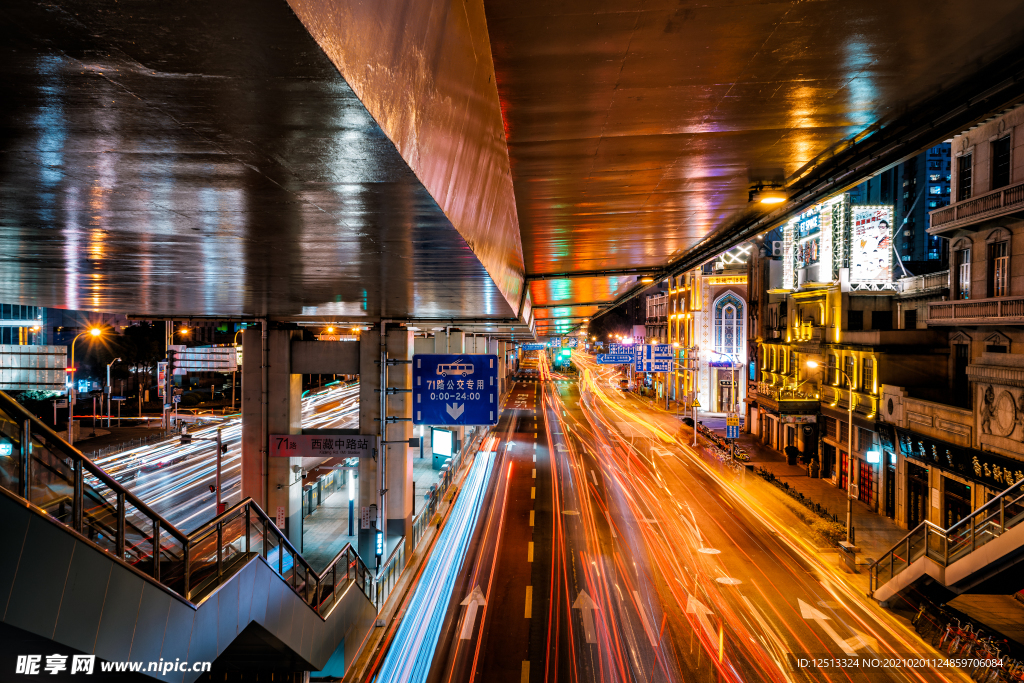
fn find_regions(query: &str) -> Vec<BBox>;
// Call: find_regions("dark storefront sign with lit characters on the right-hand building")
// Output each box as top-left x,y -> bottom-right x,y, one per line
878,423 -> 1024,490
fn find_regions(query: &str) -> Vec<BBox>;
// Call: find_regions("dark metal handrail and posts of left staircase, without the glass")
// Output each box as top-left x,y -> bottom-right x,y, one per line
0,391 -> 373,617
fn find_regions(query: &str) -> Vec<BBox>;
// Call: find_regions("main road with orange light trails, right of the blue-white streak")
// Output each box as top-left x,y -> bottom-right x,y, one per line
430,354 -> 967,683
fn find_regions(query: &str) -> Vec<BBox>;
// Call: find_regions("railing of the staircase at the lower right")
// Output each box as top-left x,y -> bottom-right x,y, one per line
868,479 -> 1024,593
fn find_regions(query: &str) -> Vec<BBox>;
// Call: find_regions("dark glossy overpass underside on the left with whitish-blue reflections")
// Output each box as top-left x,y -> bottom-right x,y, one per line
0,0 -> 515,318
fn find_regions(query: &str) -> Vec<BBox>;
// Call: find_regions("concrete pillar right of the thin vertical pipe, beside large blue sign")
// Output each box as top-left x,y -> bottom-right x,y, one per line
386,327 -> 414,557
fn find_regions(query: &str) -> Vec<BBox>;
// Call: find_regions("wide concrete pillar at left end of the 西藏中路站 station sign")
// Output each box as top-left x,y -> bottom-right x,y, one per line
242,330 -> 302,548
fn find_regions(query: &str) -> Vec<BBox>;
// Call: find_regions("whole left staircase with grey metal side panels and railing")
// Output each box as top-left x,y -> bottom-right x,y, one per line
0,392 -> 380,683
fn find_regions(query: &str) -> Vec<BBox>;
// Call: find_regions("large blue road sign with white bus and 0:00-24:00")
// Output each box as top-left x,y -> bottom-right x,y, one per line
413,353 -> 500,426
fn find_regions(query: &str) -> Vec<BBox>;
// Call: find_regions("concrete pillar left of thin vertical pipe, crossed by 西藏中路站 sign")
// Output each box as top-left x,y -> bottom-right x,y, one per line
356,327 -> 382,567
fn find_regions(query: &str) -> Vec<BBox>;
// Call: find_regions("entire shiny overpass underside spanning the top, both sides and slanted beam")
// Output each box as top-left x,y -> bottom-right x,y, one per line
0,0 -> 1024,336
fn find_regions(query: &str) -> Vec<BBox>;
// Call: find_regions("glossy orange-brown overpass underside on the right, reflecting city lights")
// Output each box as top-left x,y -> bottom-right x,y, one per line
485,0 -> 1024,313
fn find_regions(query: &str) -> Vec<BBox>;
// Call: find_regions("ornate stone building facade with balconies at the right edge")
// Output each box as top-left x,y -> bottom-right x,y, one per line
880,109 -> 1024,527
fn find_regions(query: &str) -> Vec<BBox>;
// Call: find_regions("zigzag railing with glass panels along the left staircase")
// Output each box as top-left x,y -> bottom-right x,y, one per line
0,391 -> 376,617
